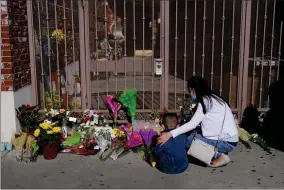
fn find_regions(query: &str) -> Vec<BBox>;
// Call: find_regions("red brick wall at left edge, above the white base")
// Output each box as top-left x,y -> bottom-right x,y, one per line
1,0 -> 31,91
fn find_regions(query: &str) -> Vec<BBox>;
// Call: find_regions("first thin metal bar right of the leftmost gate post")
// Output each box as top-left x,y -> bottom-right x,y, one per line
37,1 -> 45,109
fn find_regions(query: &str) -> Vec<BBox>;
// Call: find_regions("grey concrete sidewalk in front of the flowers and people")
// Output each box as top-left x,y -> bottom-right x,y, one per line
1,144 -> 284,189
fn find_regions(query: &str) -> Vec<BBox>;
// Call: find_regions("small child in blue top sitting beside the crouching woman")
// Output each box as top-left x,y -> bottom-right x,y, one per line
152,113 -> 188,174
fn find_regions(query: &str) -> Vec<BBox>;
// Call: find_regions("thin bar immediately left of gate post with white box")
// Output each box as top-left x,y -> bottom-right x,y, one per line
151,0 -> 155,110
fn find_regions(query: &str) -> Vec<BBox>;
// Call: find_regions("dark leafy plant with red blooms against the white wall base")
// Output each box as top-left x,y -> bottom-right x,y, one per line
16,105 -> 43,134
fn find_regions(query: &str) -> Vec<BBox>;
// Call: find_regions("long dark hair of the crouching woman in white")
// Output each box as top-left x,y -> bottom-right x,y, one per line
187,76 -> 229,114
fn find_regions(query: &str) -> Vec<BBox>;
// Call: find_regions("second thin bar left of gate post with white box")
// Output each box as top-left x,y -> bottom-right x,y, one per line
142,0 -> 145,109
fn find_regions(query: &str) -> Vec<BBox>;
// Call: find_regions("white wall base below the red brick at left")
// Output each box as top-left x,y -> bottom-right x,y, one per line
0,85 -> 32,142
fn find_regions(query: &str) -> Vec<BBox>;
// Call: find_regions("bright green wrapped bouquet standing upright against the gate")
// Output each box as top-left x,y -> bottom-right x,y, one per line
119,88 -> 137,121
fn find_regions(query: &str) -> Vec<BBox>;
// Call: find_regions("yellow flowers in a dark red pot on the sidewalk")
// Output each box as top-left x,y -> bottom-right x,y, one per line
34,121 -> 61,160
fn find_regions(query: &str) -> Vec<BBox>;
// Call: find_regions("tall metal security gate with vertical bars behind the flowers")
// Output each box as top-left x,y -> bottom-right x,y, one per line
27,0 -> 282,119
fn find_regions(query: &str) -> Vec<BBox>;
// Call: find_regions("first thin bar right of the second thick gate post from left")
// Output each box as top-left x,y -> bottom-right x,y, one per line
95,0 -> 100,110
